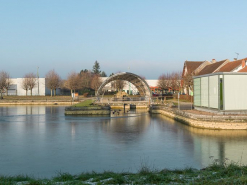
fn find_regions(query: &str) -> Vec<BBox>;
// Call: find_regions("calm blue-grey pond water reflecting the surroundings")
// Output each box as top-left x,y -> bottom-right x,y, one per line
0,106 -> 247,177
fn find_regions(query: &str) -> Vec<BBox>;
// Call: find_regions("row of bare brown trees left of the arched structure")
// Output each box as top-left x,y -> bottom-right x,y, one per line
0,61 -> 107,98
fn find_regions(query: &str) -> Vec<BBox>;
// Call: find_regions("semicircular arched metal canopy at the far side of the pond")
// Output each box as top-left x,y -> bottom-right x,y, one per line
96,72 -> 152,99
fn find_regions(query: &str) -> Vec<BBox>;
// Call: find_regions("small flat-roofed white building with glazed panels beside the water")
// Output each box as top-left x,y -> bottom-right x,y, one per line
193,72 -> 247,111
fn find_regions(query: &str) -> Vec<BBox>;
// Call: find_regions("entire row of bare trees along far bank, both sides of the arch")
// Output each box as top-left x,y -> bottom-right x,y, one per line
0,61 -> 185,97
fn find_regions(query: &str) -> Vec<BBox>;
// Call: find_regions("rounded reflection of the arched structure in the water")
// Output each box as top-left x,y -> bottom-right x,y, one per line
102,110 -> 151,143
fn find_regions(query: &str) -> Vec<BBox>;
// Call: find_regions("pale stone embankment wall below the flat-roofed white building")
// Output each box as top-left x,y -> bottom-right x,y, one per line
150,107 -> 247,130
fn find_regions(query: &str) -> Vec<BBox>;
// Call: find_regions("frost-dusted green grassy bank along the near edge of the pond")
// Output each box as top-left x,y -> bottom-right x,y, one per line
0,163 -> 247,185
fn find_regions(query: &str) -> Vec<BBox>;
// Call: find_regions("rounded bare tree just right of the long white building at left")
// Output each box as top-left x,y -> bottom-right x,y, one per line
45,69 -> 61,96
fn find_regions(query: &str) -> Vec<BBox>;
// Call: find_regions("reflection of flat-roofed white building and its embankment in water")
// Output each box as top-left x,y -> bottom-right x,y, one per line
188,127 -> 247,166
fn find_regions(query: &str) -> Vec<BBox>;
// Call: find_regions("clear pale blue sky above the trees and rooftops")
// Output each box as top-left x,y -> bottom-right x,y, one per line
0,0 -> 247,79
